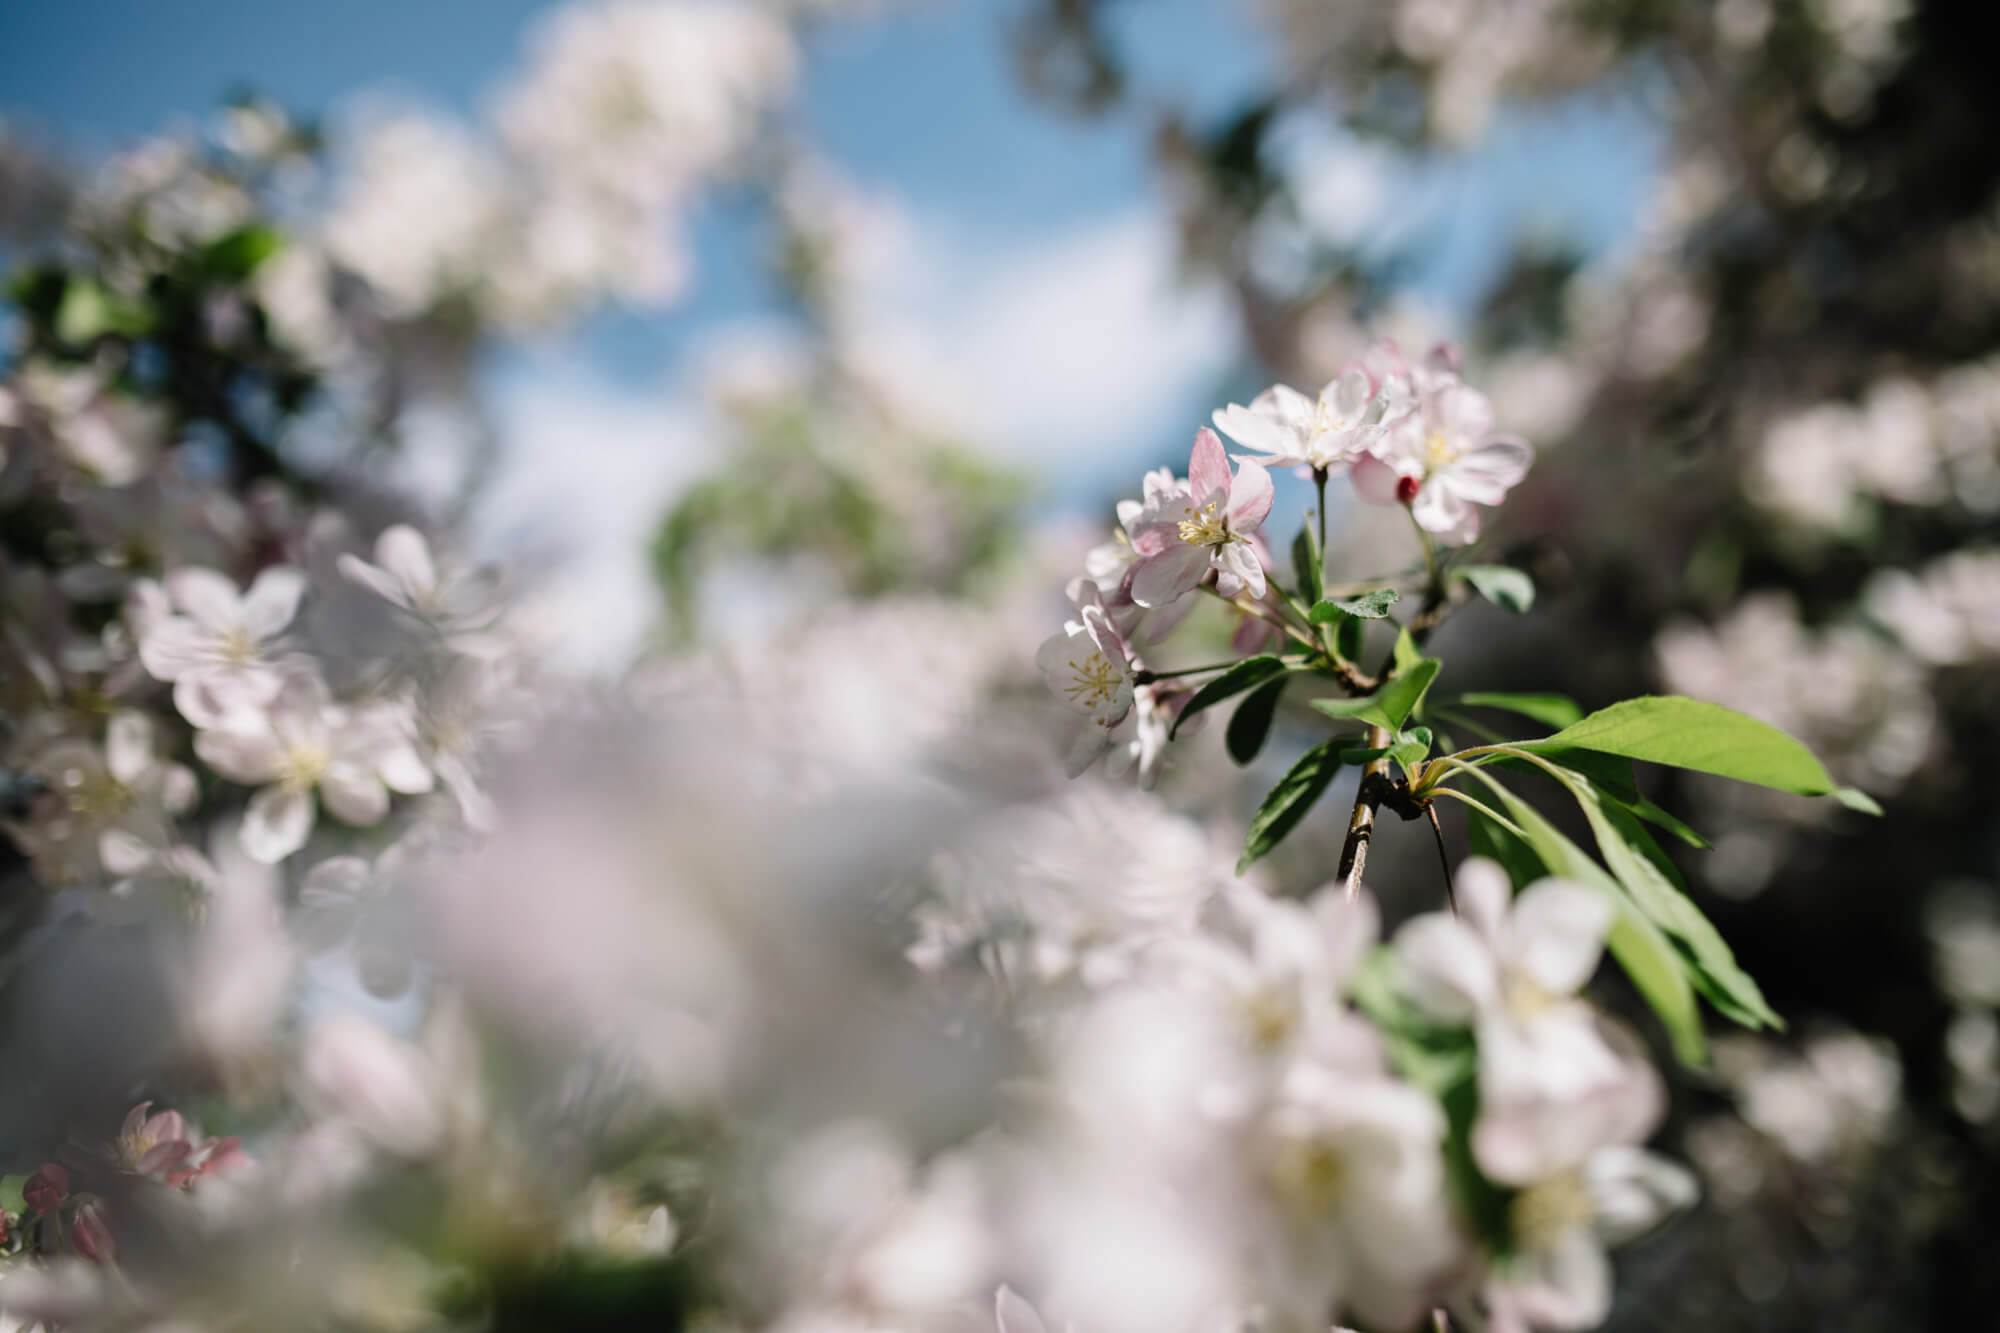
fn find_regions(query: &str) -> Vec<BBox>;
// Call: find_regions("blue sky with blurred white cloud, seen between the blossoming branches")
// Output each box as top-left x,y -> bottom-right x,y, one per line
0,0 -> 1654,656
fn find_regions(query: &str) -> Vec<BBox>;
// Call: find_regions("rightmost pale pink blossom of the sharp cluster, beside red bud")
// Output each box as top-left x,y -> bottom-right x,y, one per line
1352,382 -> 1534,546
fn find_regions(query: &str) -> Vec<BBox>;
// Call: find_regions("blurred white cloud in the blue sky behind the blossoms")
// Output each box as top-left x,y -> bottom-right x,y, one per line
476,201 -> 1234,669
